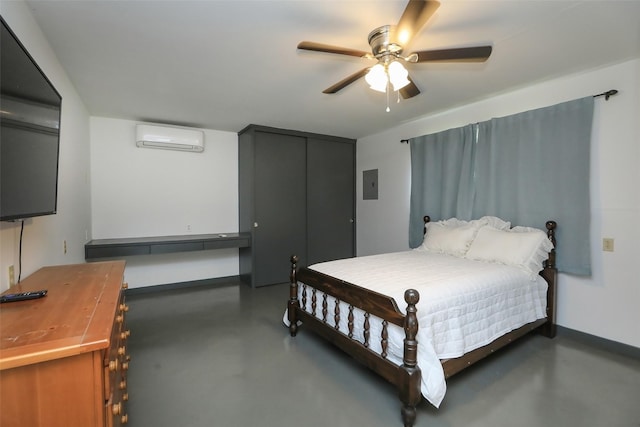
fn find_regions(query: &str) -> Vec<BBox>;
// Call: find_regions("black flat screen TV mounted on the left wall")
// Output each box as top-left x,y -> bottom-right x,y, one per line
0,17 -> 62,221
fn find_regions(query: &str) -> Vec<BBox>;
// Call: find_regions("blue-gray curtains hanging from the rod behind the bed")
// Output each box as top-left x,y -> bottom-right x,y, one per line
409,96 -> 593,275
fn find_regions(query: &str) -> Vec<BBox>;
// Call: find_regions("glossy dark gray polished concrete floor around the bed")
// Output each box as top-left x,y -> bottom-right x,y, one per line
127,284 -> 640,427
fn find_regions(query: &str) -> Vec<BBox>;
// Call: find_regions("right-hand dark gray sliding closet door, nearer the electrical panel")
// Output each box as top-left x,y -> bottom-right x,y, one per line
307,138 -> 355,264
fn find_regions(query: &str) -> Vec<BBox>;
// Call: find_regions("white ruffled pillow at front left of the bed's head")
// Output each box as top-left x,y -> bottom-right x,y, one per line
422,220 -> 478,257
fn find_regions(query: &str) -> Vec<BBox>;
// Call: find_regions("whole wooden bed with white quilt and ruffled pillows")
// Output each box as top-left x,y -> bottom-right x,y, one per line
284,216 -> 557,426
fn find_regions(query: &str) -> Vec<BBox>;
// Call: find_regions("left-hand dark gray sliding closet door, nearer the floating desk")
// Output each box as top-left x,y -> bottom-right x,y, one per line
252,132 -> 307,286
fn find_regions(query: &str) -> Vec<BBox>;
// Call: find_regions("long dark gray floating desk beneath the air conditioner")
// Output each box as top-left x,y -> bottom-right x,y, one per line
84,233 -> 251,260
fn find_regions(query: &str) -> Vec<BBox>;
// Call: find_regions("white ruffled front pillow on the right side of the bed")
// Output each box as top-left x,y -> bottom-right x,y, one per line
465,226 -> 553,279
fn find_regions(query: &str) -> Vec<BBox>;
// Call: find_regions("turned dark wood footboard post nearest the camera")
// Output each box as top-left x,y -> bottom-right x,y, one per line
399,289 -> 421,427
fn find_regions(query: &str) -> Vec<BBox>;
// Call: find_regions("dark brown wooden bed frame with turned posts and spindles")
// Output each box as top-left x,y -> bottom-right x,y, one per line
287,216 -> 557,427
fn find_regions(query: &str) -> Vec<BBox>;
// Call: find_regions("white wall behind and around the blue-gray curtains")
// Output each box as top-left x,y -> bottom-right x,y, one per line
356,59 -> 640,347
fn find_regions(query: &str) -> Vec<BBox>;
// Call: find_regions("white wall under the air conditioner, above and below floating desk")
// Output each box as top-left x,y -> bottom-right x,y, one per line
91,117 -> 238,288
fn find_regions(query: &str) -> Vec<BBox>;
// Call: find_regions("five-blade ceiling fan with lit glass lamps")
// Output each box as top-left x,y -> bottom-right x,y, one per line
298,0 -> 492,102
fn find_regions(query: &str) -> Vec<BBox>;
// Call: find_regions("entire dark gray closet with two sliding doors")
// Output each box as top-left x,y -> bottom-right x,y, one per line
238,125 -> 356,287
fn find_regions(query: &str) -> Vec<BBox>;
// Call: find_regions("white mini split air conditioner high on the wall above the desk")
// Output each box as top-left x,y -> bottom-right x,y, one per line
136,125 -> 204,153
